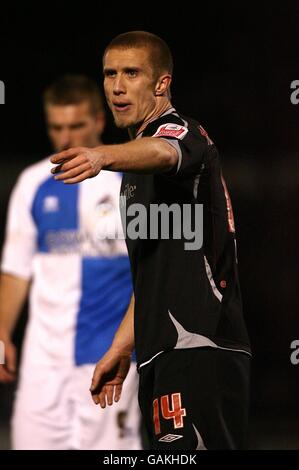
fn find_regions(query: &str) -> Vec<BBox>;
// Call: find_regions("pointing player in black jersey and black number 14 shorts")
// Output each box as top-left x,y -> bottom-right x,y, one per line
51,31 -> 250,450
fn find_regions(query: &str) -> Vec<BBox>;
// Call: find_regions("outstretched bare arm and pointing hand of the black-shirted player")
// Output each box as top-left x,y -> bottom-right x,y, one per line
50,137 -> 178,183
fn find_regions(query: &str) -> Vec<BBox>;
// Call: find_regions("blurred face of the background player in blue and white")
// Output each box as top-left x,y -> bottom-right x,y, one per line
46,101 -> 104,152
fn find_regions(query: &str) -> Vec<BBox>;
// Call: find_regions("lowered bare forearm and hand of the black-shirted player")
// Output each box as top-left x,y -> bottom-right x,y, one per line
90,295 -> 135,408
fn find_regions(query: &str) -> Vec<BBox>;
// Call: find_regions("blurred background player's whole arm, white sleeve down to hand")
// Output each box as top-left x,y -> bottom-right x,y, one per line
0,173 -> 36,382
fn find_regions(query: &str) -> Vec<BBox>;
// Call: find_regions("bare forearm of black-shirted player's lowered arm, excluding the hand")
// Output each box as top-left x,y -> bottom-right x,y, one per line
112,295 -> 135,354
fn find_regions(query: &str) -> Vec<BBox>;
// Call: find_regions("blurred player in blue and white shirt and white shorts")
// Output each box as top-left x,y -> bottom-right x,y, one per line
0,75 -> 140,450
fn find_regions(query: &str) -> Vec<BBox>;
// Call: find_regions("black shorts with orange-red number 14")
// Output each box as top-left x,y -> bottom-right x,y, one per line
138,348 -> 250,450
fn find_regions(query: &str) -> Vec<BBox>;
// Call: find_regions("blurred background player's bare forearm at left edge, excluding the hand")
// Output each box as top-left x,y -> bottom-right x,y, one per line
0,273 -> 30,337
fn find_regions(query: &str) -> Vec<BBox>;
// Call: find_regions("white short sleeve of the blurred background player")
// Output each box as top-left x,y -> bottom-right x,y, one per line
1,174 -> 37,279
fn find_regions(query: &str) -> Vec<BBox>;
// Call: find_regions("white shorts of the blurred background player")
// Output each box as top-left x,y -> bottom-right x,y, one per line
12,363 -> 141,450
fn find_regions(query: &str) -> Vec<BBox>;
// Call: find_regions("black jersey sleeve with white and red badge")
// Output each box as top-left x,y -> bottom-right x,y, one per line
151,115 -> 214,177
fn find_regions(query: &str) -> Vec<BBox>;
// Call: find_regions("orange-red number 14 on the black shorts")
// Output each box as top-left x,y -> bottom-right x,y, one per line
153,393 -> 186,435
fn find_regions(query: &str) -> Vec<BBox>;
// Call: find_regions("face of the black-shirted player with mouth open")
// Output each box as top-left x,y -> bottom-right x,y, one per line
103,48 -> 156,128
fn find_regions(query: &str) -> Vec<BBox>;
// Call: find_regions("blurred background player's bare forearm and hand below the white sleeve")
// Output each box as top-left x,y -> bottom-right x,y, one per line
0,273 -> 30,382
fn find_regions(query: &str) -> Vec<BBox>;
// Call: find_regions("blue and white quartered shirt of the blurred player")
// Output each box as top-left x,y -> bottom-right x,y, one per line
1,159 -> 132,367
